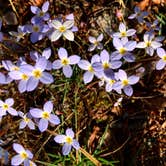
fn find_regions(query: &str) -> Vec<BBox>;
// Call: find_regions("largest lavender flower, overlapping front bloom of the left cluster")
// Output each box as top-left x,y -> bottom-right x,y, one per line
20,57 -> 53,91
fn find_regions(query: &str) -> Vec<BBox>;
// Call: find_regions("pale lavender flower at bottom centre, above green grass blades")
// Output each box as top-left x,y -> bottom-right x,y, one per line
54,129 -> 80,155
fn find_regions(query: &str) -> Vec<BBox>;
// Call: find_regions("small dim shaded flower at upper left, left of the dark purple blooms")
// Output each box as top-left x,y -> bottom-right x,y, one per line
9,25 -> 26,42
